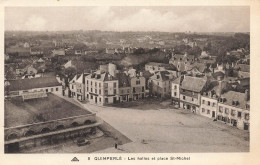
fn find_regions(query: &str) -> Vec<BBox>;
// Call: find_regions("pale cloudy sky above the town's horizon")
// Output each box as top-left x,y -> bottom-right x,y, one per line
5,6 -> 250,32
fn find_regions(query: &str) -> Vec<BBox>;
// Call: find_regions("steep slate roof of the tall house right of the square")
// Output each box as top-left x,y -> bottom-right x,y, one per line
181,76 -> 206,92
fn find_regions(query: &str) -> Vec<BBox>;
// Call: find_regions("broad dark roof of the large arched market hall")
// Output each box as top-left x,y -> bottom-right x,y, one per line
4,93 -> 90,127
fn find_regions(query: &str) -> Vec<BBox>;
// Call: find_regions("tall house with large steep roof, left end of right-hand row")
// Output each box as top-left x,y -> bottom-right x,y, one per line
180,76 -> 207,113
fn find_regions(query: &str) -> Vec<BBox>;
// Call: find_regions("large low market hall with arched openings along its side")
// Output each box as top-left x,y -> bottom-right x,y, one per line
4,93 -> 101,153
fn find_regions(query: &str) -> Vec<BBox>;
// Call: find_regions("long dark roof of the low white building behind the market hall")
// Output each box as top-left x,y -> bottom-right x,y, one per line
9,77 -> 61,91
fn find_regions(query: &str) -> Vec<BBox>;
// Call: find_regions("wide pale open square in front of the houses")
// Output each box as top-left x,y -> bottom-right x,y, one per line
79,102 -> 249,153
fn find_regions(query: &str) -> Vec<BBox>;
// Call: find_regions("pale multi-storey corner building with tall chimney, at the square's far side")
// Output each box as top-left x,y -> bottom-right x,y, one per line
85,63 -> 119,105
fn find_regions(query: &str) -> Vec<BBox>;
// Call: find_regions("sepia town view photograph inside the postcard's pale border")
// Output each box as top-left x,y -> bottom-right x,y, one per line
2,5 -> 252,154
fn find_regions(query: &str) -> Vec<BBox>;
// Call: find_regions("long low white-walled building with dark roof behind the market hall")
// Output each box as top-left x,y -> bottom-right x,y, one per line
5,77 -> 62,97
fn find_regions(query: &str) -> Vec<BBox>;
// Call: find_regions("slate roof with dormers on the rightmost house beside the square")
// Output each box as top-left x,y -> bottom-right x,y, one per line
221,91 -> 248,109
